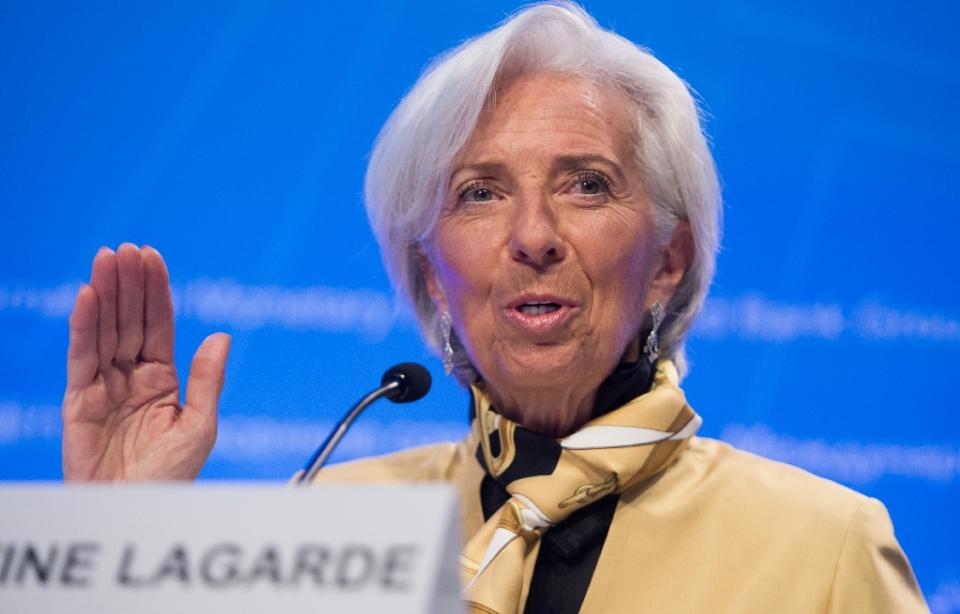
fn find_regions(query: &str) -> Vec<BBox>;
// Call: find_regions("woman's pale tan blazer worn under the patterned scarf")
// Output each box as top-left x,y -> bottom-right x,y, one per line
318,437 -> 929,614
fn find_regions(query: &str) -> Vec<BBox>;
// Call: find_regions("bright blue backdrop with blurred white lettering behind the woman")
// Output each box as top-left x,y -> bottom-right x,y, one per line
0,0 -> 960,612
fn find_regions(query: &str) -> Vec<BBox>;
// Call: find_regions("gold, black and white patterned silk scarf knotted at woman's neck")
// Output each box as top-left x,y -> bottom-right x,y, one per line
460,360 -> 701,614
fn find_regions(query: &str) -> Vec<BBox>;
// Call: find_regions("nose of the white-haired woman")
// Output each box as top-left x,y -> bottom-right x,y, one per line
510,194 -> 567,268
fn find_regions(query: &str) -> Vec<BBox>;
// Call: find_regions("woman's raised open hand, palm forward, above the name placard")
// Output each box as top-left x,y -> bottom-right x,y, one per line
63,243 -> 230,480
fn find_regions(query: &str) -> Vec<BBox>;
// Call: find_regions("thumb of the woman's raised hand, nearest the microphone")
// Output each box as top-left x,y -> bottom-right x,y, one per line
183,333 -> 230,444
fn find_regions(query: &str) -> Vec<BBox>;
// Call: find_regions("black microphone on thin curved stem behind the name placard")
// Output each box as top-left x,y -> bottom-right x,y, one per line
296,362 -> 432,486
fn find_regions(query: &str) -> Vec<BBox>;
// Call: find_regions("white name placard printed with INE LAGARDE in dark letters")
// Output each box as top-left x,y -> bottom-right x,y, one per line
0,484 -> 463,614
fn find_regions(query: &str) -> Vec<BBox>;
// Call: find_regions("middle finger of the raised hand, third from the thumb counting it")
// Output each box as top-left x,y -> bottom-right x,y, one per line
116,243 -> 144,365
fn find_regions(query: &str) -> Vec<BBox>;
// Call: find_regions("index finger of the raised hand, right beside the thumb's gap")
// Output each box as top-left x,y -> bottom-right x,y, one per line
140,246 -> 173,362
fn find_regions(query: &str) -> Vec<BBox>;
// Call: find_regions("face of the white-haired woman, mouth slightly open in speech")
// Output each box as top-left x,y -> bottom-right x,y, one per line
426,74 -> 686,434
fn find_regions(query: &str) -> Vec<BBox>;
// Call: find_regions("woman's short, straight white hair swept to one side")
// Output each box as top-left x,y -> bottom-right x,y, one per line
364,2 -> 721,381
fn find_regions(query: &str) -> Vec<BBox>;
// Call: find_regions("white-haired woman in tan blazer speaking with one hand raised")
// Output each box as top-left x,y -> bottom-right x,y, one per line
58,5 -> 924,613
